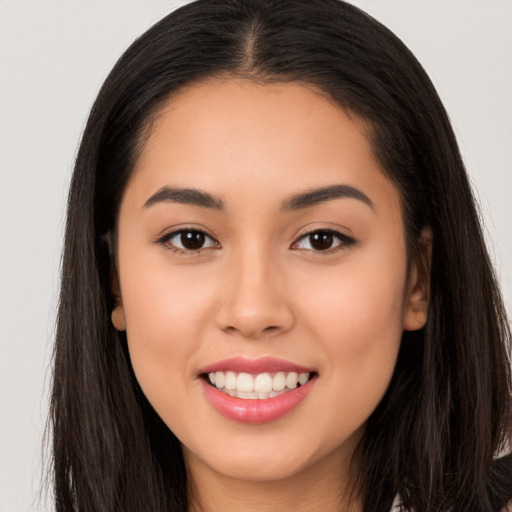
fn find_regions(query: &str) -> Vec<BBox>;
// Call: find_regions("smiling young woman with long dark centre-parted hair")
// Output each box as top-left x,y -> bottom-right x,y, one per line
52,0 -> 512,512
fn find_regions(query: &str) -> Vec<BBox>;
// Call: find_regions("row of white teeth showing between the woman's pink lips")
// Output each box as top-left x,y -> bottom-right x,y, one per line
202,371 -> 316,400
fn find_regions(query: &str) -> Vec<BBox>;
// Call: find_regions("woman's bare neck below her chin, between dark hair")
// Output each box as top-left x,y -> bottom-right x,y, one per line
184,446 -> 362,512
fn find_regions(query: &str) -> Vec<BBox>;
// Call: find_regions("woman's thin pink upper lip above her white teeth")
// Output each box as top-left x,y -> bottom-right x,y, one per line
198,356 -> 314,375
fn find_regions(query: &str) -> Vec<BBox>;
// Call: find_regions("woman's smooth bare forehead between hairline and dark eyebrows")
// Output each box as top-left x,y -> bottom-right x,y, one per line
128,79 -> 398,219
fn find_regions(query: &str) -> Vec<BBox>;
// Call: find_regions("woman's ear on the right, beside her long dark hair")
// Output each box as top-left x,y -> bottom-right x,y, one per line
404,227 -> 432,331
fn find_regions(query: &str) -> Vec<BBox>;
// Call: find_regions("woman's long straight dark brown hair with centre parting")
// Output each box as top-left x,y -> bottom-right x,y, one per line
51,0 -> 512,512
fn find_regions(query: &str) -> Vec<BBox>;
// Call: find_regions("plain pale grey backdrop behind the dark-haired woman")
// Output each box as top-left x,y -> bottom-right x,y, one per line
0,0 -> 512,512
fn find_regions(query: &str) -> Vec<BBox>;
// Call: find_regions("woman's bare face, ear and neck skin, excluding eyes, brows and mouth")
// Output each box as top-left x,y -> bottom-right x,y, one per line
113,79 -> 427,511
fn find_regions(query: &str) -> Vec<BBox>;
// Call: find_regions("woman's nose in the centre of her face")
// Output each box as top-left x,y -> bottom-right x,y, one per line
216,245 -> 295,339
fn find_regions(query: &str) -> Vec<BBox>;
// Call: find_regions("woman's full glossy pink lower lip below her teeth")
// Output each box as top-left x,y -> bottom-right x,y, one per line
201,376 -> 317,423
